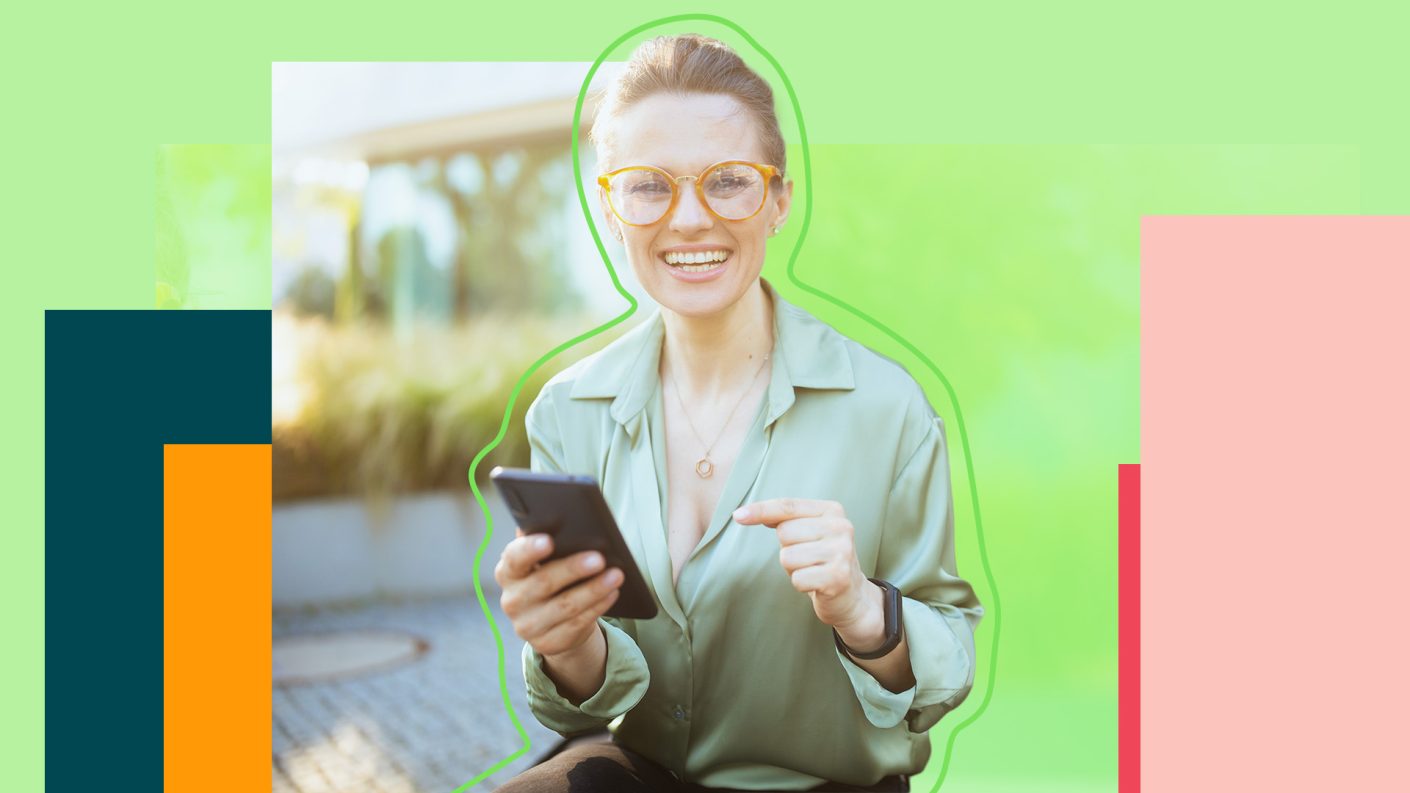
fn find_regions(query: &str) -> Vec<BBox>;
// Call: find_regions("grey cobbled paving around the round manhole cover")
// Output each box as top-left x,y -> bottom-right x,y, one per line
274,592 -> 558,793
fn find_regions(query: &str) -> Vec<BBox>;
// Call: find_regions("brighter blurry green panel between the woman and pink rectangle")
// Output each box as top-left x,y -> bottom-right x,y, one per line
789,145 -> 1362,793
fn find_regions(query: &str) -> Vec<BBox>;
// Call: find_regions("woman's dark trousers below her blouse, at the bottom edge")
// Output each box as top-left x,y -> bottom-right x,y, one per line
495,741 -> 909,793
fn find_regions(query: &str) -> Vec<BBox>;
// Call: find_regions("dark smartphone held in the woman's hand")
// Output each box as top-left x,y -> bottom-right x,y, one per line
489,466 -> 656,619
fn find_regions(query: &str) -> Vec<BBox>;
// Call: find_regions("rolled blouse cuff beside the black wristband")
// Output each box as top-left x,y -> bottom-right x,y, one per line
833,597 -> 974,732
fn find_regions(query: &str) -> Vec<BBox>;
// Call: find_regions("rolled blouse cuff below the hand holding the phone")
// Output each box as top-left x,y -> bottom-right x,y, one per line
523,618 -> 651,735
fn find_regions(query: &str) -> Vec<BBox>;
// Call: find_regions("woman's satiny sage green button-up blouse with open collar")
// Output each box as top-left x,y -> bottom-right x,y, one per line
523,281 -> 984,790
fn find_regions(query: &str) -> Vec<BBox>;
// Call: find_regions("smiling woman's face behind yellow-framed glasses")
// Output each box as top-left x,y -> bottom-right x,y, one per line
599,93 -> 792,316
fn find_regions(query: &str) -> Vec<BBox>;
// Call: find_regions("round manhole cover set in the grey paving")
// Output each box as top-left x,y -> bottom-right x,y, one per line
274,631 -> 430,686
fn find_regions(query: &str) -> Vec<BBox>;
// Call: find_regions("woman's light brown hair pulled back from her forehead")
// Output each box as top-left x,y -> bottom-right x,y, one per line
588,32 -> 787,174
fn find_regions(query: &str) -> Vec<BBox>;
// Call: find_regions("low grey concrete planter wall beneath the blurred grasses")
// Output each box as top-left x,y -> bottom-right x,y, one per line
272,485 -> 515,608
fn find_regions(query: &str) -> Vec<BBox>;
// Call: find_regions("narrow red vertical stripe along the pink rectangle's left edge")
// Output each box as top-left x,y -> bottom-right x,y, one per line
1117,464 -> 1141,793
